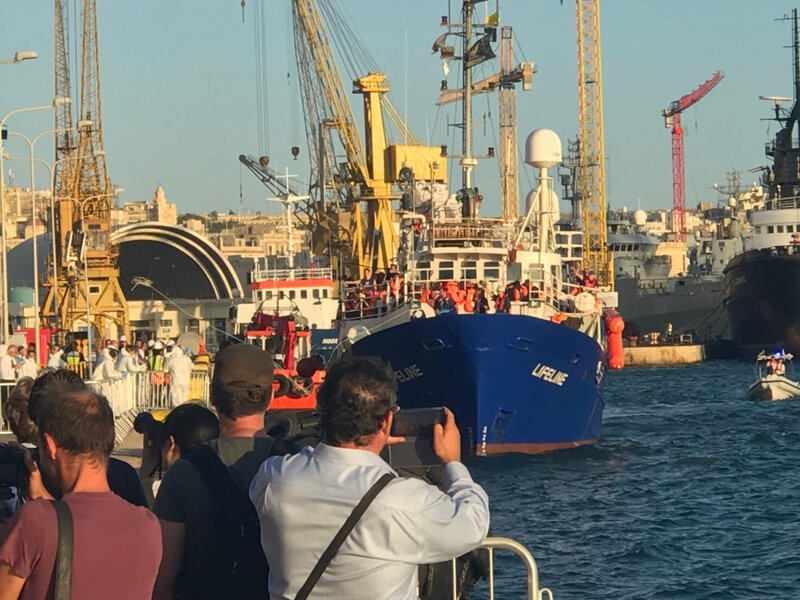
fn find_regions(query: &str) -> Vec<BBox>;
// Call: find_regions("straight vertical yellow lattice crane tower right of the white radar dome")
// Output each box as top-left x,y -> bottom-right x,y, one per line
576,0 -> 614,286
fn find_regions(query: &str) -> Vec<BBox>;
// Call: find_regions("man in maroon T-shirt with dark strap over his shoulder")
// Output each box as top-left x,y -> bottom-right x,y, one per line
0,389 -> 161,600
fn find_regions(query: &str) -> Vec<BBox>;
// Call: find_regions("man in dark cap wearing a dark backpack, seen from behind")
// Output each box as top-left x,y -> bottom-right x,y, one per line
153,344 -> 294,599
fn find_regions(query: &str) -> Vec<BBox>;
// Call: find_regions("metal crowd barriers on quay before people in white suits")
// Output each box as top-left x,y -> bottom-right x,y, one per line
86,371 -> 209,445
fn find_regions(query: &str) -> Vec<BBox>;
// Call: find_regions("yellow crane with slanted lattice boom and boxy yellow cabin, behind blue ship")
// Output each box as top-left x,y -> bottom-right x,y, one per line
292,0 -> 447,278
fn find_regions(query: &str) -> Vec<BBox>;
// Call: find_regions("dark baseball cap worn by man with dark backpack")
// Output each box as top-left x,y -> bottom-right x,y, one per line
212,344 -> 272,396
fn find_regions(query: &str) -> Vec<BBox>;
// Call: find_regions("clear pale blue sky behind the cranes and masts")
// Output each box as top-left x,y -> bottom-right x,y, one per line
0,0 -> 797,218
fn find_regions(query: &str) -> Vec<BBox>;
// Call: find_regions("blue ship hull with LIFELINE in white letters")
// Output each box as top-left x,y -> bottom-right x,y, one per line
352,314 -> 605,455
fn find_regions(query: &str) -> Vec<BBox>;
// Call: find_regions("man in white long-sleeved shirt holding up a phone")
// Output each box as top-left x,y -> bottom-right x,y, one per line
250,357 -> 489,600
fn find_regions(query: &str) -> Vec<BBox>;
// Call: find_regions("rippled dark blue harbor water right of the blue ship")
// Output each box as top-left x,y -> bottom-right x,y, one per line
469,361 -> 800,600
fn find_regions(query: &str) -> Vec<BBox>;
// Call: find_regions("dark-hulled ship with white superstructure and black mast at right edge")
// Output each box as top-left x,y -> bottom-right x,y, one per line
725,9 -> 800,355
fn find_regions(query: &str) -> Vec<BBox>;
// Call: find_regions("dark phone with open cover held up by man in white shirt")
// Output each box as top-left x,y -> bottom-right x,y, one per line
382,406 -> 445,469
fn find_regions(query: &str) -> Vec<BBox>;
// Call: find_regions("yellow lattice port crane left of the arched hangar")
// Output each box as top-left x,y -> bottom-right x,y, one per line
41,0 -> 128,350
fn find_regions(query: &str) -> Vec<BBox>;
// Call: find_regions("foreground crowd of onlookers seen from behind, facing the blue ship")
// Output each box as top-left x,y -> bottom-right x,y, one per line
0,344 -> 489,600
